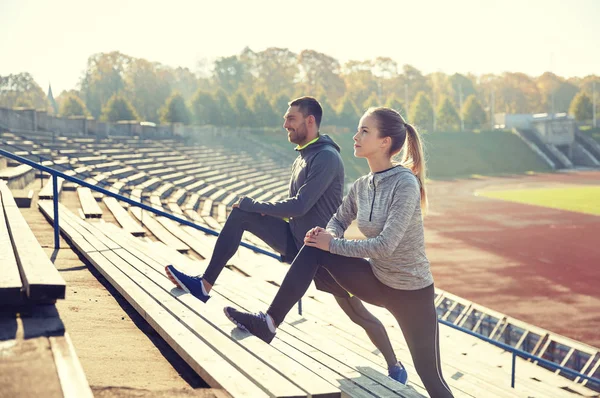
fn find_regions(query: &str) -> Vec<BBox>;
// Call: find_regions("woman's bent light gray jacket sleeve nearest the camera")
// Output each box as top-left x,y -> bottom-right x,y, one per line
329,178 -> 420,258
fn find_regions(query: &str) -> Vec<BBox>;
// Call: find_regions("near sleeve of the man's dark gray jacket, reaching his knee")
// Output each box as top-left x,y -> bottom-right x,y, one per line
240,150 -> 341,218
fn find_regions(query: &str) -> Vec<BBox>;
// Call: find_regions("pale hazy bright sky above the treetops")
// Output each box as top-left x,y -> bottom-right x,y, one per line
0,0 -> 600,95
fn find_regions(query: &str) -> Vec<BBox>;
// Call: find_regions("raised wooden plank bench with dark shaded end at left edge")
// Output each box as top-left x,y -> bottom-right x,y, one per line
0,181 -> 65,305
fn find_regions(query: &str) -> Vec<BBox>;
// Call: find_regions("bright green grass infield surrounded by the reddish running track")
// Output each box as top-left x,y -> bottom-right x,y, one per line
478,186 -> 600,216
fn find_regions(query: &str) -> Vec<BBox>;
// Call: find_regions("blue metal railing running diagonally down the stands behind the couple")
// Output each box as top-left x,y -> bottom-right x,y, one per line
0,149 -> 600,388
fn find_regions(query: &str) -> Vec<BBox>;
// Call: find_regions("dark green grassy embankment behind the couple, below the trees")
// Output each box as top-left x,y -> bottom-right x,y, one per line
253,130 -> 551,182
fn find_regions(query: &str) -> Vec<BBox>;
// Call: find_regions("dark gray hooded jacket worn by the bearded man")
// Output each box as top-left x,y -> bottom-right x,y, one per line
240,135 -> 344,250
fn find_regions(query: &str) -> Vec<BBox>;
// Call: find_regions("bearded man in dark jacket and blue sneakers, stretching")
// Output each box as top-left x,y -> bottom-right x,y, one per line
165,97 -> 406,383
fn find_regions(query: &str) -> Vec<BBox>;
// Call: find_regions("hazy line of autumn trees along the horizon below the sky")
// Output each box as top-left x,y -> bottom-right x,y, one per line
0,48 -> 600,131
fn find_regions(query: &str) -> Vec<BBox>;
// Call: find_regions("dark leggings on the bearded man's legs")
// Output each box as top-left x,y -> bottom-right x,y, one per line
202,208 -> 397,367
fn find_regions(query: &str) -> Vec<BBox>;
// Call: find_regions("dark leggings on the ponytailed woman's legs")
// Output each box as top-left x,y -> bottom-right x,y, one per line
267,246 -> 452,398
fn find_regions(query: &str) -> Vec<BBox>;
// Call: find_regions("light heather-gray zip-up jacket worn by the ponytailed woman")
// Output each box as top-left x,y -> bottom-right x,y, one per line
326,166 -> 433,290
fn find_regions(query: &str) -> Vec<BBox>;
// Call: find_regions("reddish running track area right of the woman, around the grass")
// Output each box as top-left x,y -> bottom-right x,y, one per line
425,171 -> 600,347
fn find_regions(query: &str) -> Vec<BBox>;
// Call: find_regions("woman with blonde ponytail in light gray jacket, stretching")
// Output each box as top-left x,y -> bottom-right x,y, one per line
225,108 -> 452,397
